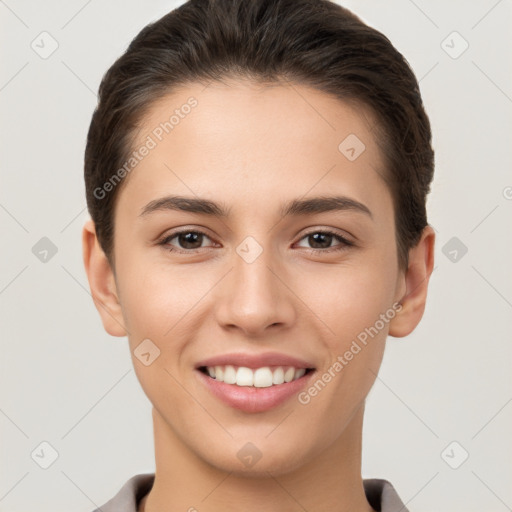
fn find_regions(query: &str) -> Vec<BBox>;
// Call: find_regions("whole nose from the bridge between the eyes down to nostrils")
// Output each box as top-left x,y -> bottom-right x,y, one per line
217,237 -> 295,334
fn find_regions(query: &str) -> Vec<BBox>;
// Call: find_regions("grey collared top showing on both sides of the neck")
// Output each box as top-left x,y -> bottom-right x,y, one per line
93,473 -> 409,512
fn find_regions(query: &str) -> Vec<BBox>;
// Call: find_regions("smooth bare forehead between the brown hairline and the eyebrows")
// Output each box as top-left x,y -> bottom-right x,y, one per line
120,81 -> 384,220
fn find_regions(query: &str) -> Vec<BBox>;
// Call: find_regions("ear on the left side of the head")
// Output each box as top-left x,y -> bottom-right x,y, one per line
82,219 -> 127,336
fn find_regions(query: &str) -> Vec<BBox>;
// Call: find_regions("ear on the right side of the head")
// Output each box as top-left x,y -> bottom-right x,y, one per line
389,226 -> 435,338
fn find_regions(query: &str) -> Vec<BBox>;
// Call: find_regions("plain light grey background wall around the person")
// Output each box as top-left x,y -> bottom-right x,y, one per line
0,0 -> 512,512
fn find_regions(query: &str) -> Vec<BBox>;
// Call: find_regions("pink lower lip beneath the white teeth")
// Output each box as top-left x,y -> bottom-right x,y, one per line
196,370 -> 316,412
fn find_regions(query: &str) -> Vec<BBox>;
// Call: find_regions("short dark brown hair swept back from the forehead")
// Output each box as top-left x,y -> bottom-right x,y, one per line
84,0 -> 434,269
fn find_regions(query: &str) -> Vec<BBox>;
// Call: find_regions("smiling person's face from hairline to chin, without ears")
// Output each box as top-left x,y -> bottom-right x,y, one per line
100,81 -> 405,474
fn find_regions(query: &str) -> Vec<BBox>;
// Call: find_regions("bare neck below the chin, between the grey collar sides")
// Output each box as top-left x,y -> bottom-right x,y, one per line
138,404 -> 374,512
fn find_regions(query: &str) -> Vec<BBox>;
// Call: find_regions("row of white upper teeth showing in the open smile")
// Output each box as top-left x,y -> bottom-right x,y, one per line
206,364 -> 306,388
